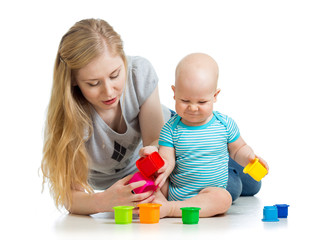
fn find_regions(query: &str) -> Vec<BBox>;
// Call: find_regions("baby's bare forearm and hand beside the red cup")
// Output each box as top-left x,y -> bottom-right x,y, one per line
155,146 -> 176,189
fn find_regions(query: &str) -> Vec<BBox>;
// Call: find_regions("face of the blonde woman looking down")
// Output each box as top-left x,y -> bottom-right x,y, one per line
75,50 -> 126,113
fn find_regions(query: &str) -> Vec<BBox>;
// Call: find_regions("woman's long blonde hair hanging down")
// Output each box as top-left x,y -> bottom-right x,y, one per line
41,19 -> 127,208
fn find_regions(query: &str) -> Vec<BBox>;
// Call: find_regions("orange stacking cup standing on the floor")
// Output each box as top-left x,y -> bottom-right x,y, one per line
138,203 -> 162,223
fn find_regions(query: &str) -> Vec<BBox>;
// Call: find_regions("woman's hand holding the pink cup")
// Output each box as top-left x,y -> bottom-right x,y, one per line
99,175 -> 155,213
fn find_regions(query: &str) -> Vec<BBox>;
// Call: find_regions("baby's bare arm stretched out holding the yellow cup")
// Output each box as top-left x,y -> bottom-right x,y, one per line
228,136 -> 269,170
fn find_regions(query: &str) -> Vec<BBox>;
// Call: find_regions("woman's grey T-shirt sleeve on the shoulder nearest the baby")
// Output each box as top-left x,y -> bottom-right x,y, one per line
131,57 -> 158,107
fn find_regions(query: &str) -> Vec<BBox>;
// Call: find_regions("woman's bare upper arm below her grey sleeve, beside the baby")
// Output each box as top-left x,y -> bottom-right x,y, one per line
139,86 -> 164,146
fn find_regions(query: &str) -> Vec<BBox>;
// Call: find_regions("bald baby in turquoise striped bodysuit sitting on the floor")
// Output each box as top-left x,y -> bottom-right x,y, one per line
156,53 -> 268,217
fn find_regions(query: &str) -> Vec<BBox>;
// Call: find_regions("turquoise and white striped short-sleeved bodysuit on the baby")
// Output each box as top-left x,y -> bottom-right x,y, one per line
159,111 -> 240,201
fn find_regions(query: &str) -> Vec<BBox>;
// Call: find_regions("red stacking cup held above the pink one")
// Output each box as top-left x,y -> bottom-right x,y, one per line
136,152 -> 165,178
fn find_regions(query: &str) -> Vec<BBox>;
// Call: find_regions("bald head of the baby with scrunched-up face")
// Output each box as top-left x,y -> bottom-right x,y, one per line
172,53 -> 220,126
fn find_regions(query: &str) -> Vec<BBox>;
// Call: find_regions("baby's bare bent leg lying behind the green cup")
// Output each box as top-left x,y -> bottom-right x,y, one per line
154,187 -> 232,217
